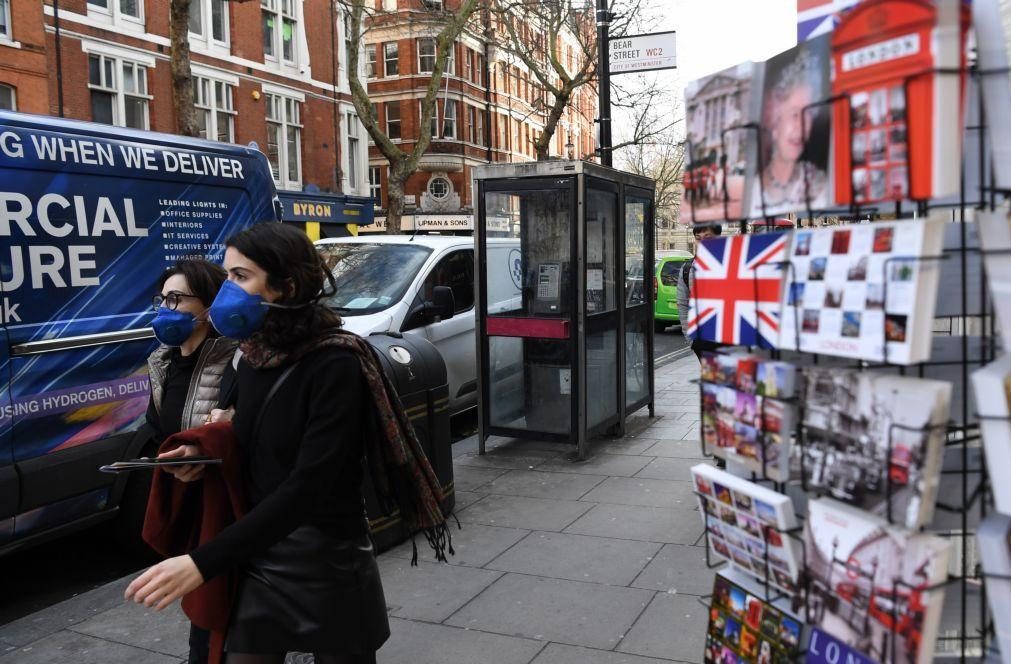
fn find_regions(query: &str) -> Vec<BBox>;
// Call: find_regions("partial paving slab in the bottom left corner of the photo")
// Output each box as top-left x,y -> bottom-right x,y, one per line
0,631 -> 182,664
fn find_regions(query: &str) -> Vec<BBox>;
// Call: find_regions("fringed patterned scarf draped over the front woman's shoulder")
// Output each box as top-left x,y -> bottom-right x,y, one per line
241,327 -> 455,565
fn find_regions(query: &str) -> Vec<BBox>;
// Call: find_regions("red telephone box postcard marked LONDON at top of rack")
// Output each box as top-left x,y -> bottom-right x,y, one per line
832,0 -> 970,204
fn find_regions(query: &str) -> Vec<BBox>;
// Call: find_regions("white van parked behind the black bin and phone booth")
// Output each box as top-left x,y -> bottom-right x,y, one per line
315,235 -> 523,414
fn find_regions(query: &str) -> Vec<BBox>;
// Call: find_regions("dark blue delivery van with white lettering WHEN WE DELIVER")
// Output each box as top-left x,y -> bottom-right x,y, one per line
0,112 -> 279,554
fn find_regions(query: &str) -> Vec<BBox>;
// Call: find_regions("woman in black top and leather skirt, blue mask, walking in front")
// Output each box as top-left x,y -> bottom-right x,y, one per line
125,223 -> 452,664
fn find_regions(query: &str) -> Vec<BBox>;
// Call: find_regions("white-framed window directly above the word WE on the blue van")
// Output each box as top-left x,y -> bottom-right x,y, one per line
88,54 -> 150,129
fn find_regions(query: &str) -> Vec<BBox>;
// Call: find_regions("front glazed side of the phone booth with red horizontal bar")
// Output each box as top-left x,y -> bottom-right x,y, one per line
478,177 -> 578,442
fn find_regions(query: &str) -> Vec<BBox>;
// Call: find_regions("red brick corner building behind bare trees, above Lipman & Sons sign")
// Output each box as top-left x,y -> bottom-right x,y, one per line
363,0 -> 596,231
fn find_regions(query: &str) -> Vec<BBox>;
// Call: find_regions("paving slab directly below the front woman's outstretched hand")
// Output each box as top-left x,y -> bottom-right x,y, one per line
72,602 -> 189,659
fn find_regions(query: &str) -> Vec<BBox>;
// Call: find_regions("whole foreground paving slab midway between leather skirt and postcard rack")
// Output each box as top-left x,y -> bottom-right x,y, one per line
446,574 -> 651,652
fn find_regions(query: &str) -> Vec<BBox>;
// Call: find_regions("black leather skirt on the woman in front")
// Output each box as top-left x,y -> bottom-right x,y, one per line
224,526 -> 389,654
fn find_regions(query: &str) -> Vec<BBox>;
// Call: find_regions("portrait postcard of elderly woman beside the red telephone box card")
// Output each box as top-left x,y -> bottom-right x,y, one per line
747,34 -> 832,218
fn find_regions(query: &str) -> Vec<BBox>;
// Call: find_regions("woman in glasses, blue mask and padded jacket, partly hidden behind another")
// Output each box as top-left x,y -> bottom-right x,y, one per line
142,260 -> 238,664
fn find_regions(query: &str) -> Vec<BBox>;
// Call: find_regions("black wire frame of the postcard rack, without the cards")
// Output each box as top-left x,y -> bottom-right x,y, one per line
685,67 -> 1011,662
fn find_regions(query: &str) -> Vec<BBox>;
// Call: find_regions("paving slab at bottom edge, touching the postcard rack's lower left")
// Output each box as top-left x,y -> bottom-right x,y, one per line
616,593 -> 709,662
